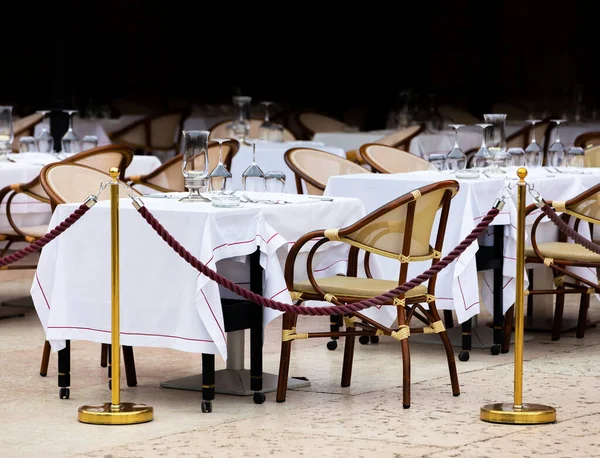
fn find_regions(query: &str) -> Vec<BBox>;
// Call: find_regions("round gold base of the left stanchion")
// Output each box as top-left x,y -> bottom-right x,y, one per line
77,402 -> 154,425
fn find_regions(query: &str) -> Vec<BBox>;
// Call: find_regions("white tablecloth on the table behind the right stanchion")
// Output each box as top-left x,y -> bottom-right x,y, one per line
325,169 -> 600,323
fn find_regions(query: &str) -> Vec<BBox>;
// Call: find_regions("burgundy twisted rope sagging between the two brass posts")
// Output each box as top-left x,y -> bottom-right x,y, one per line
138,206 -> 500,315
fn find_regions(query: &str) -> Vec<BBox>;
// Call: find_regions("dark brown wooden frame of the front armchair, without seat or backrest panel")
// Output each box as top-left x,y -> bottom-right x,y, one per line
277,180 -> 460,408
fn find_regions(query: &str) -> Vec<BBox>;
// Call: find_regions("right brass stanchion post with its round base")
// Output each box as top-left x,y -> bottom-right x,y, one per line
480,167 -> 556,425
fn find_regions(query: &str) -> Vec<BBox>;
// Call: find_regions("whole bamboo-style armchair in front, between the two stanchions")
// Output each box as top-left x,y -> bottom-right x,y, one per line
277,181 -> 460,408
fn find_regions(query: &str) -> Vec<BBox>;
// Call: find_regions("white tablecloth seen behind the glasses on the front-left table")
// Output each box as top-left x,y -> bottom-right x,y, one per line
231,141 -> 346,194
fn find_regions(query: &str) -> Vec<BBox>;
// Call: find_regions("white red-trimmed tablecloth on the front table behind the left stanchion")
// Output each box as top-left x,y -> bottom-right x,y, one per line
31,194 -> 364,358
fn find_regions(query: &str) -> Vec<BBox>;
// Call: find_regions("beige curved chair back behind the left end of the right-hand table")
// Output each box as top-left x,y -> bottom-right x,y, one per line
359,143 -> 430,173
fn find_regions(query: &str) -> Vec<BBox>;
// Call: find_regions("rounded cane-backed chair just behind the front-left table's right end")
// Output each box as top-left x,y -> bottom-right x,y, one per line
283,148 -> 370,195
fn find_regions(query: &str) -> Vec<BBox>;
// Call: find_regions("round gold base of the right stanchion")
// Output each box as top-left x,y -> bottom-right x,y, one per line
480,403 -> 556,425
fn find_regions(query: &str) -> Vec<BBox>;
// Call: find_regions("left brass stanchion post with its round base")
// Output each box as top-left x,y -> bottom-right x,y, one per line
78,167 -> 154,425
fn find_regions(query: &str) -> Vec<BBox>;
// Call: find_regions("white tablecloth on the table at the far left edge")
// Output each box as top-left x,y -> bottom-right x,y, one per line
0,153 -> 160,231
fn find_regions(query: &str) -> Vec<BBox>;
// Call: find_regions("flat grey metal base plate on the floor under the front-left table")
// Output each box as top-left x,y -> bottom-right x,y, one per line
160,369 -> 310,396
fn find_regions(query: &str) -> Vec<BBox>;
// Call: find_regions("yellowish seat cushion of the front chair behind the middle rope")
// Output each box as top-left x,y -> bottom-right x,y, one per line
294,275 -> 427,298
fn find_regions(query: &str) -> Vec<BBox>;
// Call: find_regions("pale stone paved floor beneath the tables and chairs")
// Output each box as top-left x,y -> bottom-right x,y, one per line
0,272 -> 600,458
